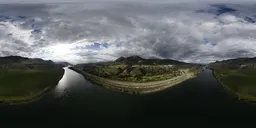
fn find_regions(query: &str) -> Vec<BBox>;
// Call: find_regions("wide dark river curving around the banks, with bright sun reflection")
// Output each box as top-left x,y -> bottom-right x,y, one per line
0,68 -> 256,127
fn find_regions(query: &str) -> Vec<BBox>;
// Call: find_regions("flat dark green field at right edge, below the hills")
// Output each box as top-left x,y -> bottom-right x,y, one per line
214,68 -> 256,101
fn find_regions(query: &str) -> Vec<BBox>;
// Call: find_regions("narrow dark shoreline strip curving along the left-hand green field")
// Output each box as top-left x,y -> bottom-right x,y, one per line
0,69 -> 65,105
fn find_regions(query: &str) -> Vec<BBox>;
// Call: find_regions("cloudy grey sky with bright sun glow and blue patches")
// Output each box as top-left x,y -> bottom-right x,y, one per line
0,0 -> 256,64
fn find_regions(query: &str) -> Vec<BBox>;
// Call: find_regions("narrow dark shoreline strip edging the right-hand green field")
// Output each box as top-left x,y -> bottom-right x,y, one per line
211,69 -> 256,103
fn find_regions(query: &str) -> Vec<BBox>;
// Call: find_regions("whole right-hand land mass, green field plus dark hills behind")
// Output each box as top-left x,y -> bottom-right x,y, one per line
208,58 -> 256,101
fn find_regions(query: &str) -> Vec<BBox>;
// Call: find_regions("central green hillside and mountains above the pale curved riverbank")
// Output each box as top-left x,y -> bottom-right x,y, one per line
76,56 -> 201,82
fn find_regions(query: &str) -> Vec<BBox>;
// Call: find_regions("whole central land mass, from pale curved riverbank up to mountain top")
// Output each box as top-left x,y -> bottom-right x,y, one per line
70,56 -> 202,94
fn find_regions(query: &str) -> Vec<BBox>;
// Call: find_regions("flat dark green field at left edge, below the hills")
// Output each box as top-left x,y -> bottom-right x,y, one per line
0,69 -> 64,102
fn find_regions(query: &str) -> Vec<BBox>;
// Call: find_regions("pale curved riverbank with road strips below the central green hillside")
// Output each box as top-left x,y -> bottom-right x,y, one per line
69,67 -> 198,94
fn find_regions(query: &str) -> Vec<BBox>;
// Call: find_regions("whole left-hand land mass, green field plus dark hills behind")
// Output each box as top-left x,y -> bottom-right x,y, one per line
0,56 -> 64,103
